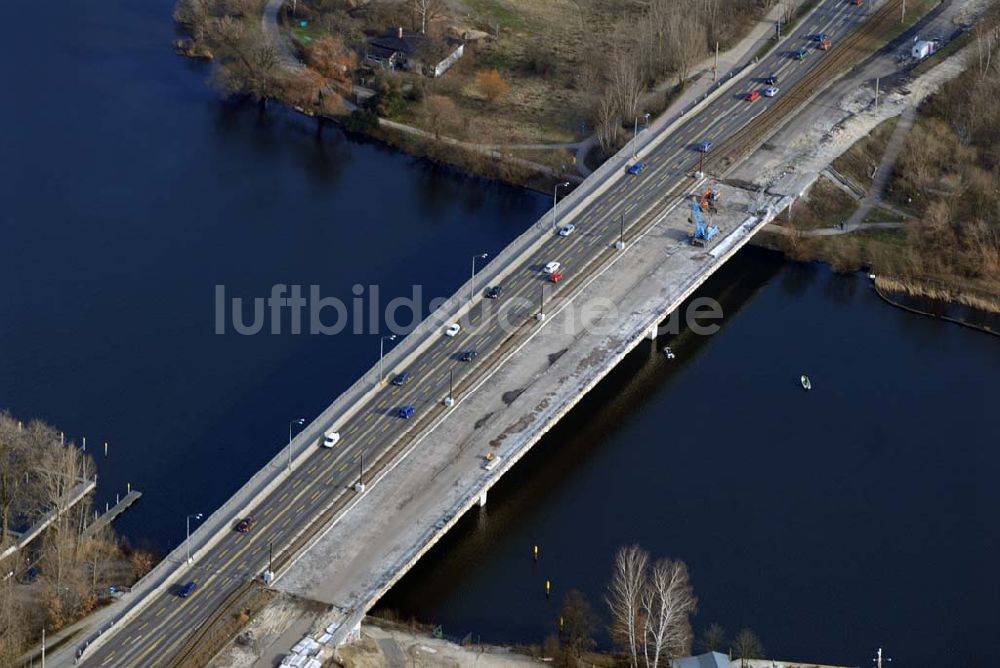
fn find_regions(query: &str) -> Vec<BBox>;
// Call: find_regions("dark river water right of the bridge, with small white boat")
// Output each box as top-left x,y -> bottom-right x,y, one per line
381,249 -> 1000,666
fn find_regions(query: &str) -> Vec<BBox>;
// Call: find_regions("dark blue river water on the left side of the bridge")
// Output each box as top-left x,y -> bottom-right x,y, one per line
0,0 -> 547,549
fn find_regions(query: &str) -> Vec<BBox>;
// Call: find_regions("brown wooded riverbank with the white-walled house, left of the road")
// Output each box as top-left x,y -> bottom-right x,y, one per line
175,0 -> 815,192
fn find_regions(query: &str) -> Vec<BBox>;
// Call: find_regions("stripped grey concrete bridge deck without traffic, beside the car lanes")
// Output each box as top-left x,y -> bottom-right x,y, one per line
274,184 -> 777,651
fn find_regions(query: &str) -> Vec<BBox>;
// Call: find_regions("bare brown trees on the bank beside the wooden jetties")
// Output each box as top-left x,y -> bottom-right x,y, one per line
0,412 -> 152,666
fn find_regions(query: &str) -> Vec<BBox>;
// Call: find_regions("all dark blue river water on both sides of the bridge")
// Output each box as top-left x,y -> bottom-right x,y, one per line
0,0 -> 1000,666
